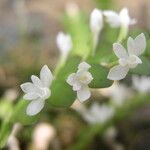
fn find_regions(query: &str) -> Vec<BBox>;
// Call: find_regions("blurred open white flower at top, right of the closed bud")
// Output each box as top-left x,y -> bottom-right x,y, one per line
103,8 -> 136,28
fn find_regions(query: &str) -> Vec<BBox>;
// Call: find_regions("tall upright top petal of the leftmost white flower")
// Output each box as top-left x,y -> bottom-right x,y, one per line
40,65 -> 53,87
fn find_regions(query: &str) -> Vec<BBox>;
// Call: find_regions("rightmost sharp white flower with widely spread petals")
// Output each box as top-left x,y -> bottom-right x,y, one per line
107,33 -> 146,80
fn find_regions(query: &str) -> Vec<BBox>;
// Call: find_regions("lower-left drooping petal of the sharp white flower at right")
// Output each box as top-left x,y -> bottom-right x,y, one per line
107,65 -> 129,80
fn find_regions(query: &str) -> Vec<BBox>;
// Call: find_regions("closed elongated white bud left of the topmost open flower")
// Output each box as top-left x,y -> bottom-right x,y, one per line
90,8 -> 103,44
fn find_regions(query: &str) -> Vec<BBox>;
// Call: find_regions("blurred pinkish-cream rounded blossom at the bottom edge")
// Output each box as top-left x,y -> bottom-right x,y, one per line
33,123 -> 56,150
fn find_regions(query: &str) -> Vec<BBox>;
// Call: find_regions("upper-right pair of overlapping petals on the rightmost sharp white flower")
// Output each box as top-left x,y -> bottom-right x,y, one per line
128,33 -> 146,56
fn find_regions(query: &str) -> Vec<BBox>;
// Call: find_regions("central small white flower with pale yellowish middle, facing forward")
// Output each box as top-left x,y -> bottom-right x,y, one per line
67,62 -> 93,102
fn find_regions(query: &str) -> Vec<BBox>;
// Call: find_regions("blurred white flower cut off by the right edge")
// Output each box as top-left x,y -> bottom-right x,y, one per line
132,76 -> 150,93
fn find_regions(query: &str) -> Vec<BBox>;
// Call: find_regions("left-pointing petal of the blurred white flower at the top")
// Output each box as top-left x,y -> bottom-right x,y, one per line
103,10 -> 120,28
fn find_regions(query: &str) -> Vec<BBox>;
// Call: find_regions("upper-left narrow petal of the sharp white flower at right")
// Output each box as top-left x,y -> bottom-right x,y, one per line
113,43 -> 128,58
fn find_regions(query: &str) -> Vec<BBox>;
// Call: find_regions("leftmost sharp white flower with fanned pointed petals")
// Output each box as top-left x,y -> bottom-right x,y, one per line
20,65 -> 53,116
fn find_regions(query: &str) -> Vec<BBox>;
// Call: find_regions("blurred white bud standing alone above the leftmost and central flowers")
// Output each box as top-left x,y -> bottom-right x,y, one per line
56,32 -> 72,58
